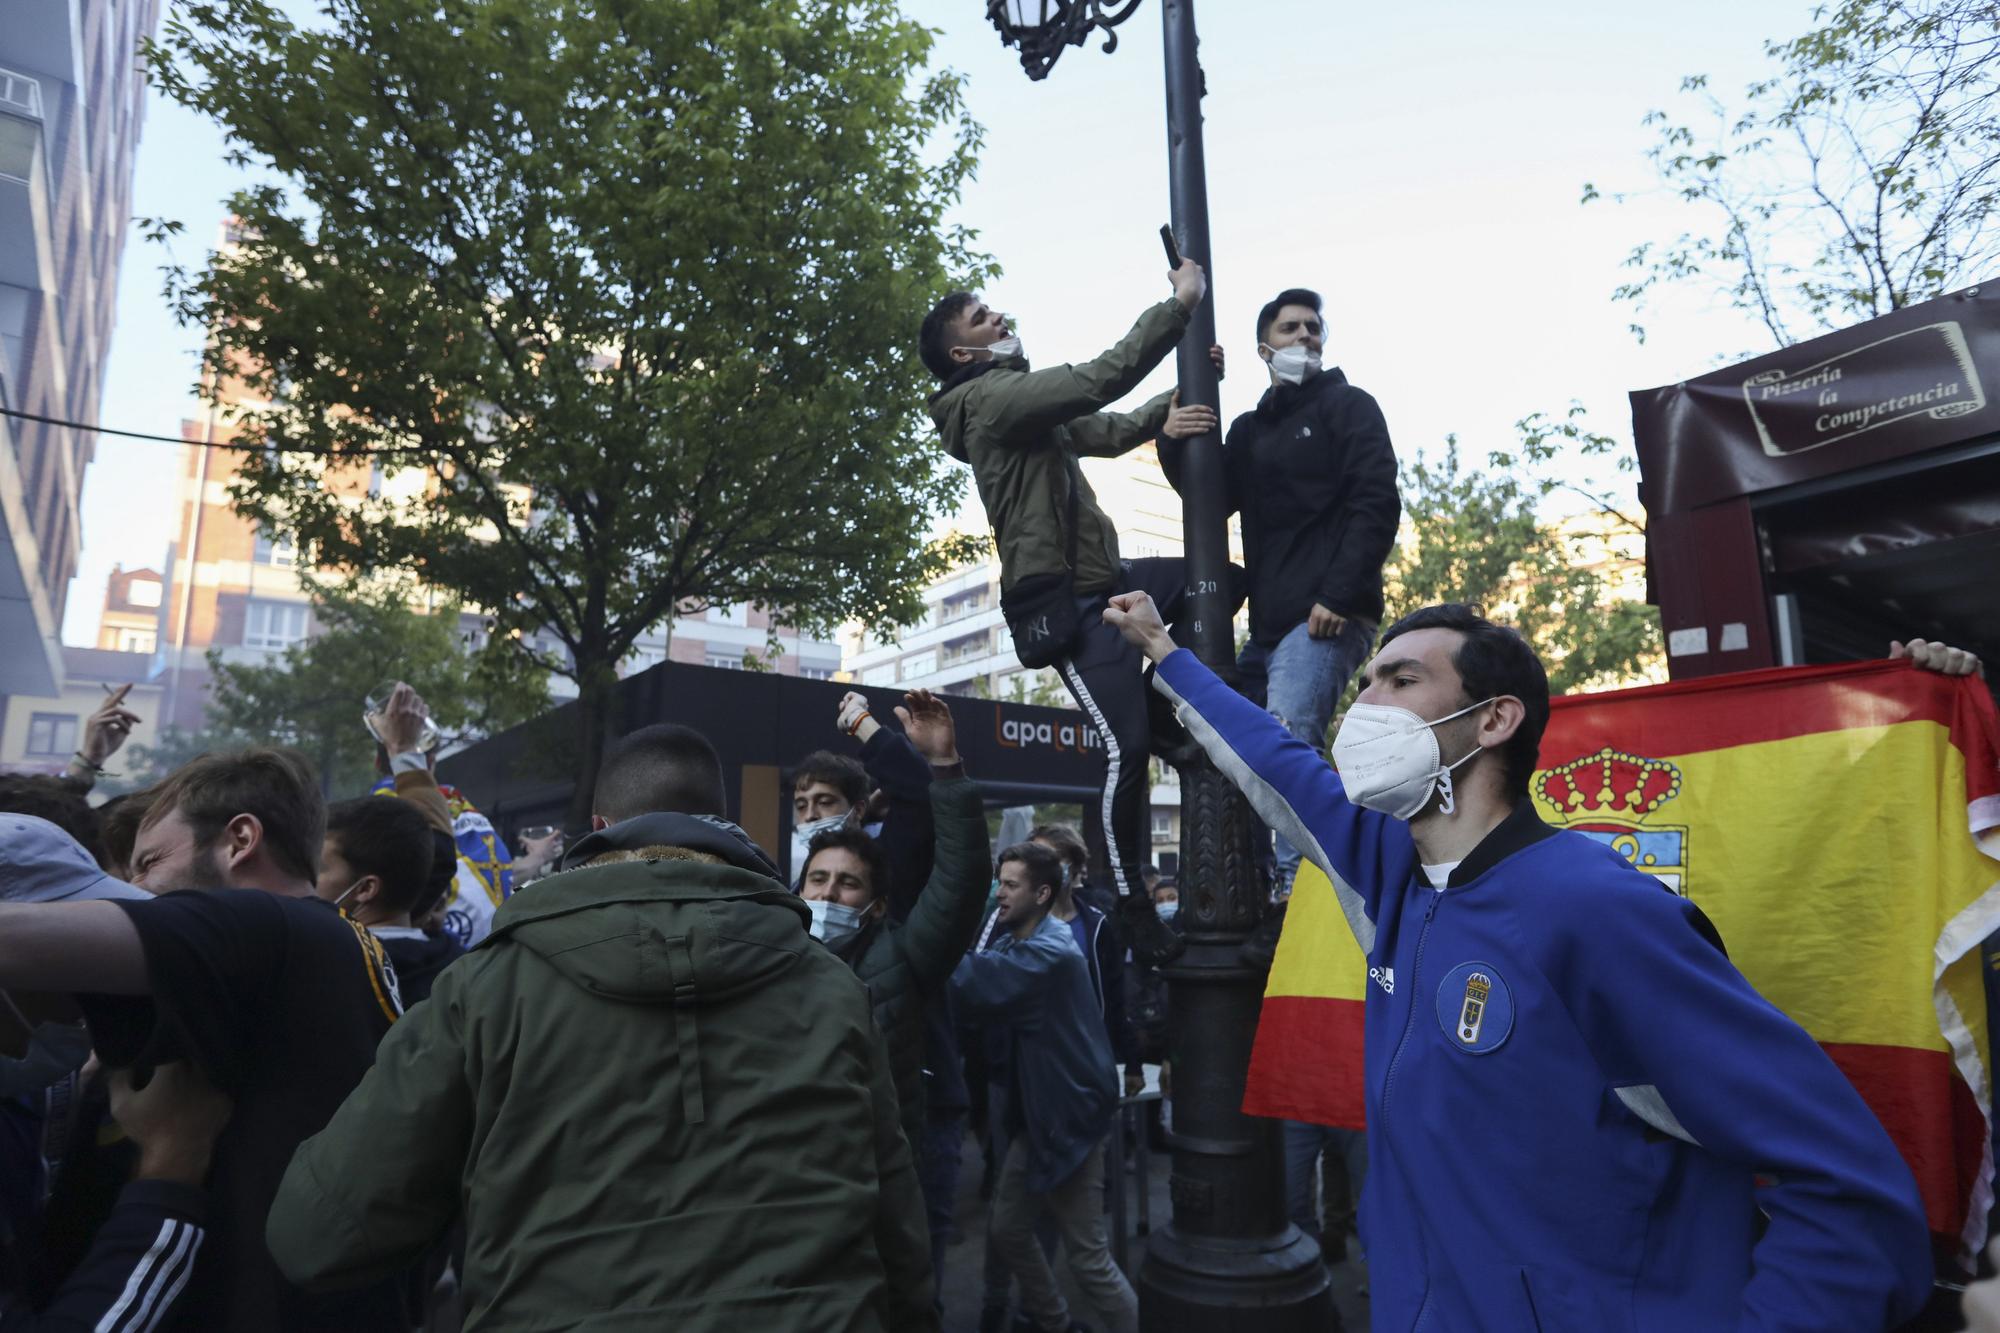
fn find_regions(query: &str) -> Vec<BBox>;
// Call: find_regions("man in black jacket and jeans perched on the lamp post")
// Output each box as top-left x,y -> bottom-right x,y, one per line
1160,286 -> 1402,897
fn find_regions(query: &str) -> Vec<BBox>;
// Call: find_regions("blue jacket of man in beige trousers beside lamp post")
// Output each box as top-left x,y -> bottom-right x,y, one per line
952,917 -> 1118,1193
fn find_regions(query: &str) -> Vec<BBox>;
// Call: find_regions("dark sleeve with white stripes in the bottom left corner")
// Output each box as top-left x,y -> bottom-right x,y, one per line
0,1181 -> 202,1333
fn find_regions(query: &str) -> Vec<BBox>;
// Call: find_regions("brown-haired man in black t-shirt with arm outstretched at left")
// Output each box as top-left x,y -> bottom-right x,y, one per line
0,749 -> 404,1333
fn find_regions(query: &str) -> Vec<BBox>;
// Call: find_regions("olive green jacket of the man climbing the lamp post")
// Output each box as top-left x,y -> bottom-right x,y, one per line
930,298 -> 1188,596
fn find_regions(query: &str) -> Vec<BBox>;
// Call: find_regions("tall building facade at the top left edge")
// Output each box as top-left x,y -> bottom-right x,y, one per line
0,0 -> 158,704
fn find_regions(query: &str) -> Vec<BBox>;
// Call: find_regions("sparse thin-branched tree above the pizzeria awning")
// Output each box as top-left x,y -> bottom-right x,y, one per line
1584,0 -> 2000,346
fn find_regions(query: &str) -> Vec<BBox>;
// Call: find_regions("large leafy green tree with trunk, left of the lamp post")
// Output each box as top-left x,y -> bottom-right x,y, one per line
150,0 -> 990,823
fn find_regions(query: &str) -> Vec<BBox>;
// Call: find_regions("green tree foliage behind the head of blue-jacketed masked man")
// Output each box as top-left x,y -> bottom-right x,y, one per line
1384,406 -> 1664,695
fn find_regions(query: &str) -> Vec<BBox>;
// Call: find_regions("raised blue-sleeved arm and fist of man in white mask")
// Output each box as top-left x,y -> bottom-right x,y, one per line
1104,592 -> 1416,953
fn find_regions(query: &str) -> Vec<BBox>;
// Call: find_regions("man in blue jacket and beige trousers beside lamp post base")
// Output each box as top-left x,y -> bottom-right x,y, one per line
952,843 -> 1150,1333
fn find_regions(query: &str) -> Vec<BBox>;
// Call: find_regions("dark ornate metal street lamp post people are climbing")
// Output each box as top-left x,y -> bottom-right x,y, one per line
986,0 -> 1340,1333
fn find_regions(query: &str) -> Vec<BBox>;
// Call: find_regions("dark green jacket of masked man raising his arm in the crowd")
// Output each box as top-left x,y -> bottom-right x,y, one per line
836,779 -> 992,1143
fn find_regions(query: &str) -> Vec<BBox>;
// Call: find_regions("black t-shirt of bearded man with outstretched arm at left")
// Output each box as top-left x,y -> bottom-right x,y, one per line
82,889 -> 408,1333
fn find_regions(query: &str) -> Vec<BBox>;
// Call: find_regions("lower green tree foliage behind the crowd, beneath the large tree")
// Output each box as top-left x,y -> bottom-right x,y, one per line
134,592 -> 548,797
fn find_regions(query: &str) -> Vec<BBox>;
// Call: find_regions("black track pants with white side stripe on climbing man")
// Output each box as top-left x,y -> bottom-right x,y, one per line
1056,556 -> 1186,897
